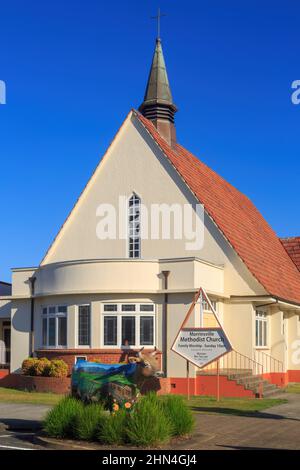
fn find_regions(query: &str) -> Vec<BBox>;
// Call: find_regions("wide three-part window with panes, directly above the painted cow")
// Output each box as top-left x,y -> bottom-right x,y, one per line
101,303 -> 155,348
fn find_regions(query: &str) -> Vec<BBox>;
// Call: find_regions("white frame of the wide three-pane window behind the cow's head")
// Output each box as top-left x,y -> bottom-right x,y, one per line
100,301 -> 157,349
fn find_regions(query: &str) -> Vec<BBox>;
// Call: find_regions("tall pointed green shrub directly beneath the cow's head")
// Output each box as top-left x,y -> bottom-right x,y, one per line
126,393 -> 172,446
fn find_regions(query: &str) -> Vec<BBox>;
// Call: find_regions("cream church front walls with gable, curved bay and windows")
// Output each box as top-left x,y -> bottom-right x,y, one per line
0,38 -> 300,392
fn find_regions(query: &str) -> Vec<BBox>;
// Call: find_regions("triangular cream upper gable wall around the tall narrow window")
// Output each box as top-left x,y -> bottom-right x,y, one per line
42,112 -> 264,295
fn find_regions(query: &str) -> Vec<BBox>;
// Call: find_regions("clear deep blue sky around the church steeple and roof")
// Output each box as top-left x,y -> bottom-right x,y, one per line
0,0 -> 300,280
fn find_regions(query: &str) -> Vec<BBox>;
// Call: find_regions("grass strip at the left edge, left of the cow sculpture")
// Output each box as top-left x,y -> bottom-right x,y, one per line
0,387 -> 63,405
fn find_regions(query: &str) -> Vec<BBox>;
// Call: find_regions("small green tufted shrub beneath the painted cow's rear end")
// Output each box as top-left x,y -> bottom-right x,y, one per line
74,403 -> 106,441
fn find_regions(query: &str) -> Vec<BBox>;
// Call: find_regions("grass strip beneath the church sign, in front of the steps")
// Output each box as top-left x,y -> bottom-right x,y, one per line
187,396 -> 287,416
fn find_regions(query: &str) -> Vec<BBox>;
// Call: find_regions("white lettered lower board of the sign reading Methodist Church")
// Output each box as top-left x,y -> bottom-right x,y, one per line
172,328 -> 231,367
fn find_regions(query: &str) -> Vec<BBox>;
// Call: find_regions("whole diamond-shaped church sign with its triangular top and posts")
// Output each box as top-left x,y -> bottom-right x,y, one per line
171,287 -> 232,401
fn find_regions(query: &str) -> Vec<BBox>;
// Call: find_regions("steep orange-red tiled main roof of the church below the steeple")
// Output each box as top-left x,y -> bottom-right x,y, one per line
136,113 -> 300,304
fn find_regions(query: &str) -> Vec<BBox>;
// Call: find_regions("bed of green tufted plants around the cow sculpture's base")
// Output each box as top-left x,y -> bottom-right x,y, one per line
44,393 -> 195,448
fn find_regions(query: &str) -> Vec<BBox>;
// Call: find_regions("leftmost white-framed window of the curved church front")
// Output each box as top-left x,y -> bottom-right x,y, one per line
42,305 -> 67,348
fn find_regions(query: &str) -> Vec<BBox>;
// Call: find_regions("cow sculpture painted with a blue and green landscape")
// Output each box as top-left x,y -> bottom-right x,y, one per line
72,349 -> 161,405
